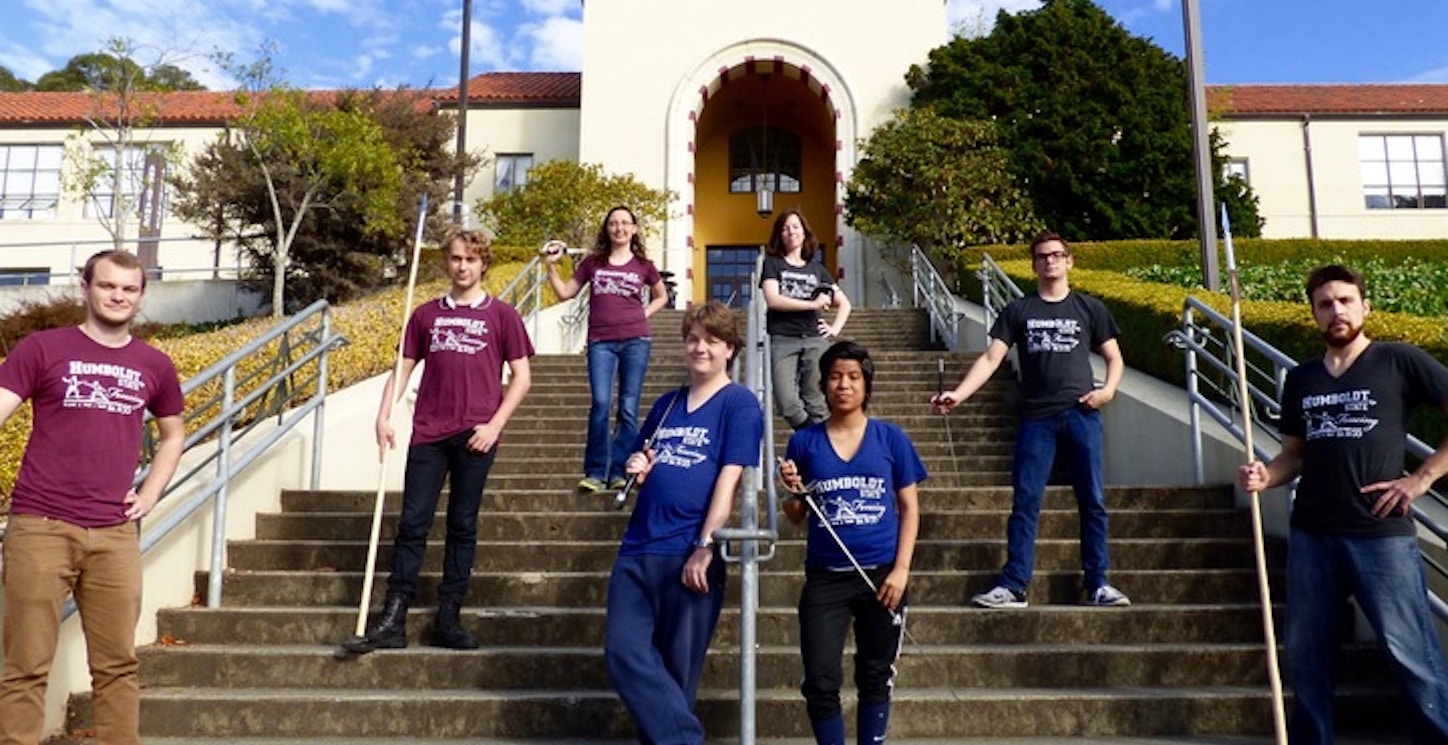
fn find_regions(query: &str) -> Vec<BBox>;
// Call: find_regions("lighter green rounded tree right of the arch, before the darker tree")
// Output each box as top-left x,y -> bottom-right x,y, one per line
844,108 -> 1041,259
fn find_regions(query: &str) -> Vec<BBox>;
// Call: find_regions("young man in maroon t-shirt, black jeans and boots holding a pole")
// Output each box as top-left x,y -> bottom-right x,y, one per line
342,230 -> 533,654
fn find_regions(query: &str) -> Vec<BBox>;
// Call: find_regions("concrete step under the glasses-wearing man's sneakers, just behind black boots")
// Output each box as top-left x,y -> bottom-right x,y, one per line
156,599 -> 1280,648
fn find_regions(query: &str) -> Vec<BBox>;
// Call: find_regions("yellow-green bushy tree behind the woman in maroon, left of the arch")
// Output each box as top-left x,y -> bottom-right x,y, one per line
478,161 -> 673,247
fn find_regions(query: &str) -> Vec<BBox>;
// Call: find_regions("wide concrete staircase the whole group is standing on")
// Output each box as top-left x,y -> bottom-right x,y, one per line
62,310 -> 1394,744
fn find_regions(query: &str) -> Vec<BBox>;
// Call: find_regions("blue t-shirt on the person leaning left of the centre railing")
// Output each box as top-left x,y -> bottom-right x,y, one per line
618,383 -> 765,555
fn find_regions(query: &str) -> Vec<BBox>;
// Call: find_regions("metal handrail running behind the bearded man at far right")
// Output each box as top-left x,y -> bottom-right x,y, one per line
1164,297 -> 1448,621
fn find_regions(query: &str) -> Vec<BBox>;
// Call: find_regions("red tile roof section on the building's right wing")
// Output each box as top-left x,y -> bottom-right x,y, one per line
1206,84 -> 1448,117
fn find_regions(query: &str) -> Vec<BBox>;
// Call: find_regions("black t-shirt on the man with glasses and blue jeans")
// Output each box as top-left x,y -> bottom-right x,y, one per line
990,291 -> 1121,420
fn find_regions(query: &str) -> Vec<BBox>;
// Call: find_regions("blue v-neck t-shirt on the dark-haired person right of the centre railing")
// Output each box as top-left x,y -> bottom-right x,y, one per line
785,418 -> 927,569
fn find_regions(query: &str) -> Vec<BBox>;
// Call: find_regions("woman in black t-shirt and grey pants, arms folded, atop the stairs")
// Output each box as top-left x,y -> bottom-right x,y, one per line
759,210 -> 850,431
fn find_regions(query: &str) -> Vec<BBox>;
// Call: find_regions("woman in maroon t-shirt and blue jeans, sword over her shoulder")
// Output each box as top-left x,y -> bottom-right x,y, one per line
546,205 -> 669,492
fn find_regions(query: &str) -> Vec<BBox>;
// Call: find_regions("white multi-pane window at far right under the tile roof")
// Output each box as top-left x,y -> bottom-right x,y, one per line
1358,135 -> 1448,210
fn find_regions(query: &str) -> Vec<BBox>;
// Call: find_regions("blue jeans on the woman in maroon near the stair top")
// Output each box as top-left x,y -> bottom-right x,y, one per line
584,336 -> 653,482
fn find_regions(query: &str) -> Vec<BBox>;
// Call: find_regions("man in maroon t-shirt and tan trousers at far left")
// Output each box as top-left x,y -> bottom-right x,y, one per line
0,250 -> 185,745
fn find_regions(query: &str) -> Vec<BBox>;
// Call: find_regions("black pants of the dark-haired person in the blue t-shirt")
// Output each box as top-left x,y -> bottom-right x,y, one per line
799,564 -> 908,720
